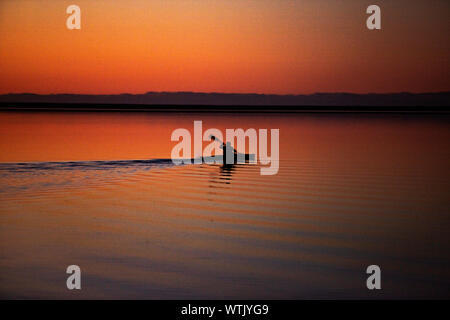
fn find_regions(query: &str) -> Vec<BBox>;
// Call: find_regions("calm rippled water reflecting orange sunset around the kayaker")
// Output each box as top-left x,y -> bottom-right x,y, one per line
0,113 -> 450,299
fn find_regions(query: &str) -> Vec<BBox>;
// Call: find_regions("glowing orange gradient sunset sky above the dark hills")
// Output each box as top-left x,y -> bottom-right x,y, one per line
0,0 -> 450,94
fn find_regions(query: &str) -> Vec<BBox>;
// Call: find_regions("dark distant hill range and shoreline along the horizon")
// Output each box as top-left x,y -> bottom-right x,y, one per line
0,91 -> 450,109
